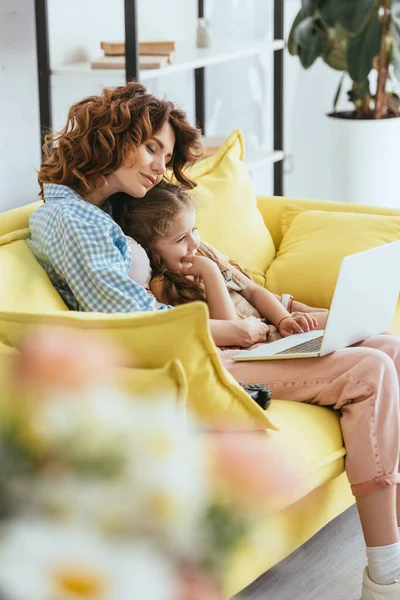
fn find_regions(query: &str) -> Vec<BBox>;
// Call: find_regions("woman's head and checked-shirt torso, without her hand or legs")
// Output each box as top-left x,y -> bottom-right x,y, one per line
29,83 -> 200,312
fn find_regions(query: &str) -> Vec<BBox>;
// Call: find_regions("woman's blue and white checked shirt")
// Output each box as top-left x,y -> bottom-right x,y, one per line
27,183 -> 169,313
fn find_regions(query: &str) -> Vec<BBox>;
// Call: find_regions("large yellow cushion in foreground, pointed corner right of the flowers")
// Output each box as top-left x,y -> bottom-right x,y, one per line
0,302 -> 276,429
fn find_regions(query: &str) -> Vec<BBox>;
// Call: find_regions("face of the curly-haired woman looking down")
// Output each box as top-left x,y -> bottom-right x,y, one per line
109,123 -> 175,198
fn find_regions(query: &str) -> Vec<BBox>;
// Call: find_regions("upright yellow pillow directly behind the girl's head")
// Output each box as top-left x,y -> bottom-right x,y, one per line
189,130 -> 275,282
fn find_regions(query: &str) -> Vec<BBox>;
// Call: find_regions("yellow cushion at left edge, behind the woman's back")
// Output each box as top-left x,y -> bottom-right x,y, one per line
0,229 -> 68,312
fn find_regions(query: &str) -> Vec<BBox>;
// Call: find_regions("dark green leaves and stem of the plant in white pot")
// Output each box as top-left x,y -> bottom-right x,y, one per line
288,0 -> 400,118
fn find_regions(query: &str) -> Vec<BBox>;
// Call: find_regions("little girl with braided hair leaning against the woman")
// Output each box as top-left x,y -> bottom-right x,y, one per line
114,182 -> 326,341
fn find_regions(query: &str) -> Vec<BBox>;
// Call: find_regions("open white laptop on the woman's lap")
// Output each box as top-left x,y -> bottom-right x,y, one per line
232,241 -> 400,361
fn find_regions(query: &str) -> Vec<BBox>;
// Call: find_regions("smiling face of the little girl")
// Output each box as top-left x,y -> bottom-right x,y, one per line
156,207 -> 200,271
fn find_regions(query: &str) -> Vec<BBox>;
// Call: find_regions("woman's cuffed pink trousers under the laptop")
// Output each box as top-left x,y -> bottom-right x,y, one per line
220,334 -> 400,496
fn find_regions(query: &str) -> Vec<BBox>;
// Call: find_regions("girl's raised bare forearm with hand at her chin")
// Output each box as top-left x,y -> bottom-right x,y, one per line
181,256 -> 238,321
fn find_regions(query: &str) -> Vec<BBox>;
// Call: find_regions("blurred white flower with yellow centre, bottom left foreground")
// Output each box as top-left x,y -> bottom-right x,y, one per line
0,520 -> 176,600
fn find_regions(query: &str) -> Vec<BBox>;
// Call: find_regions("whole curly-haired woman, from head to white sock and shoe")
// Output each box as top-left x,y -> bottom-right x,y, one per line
29,83 -> 400,600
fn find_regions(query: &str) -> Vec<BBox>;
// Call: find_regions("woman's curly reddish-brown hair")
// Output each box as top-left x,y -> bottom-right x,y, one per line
38,82 -> 201,196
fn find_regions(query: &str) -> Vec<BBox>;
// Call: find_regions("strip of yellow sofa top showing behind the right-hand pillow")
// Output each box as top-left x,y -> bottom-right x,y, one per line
257,196 -> 400,248
